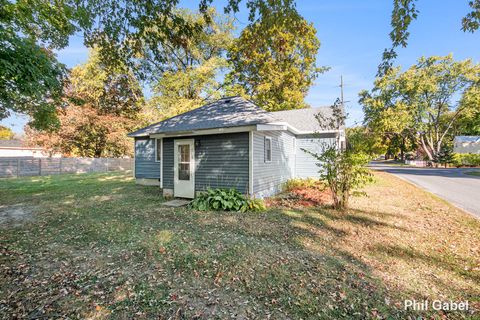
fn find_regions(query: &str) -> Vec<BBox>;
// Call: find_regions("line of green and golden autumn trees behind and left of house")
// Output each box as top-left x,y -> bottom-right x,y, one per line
0,0 -> 324,157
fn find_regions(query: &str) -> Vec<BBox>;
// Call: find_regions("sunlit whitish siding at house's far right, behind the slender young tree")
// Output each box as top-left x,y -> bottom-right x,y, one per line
295,134 -> 335,178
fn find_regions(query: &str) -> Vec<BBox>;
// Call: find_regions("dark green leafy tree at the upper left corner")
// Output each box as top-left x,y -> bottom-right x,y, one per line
0,0 -> 89,129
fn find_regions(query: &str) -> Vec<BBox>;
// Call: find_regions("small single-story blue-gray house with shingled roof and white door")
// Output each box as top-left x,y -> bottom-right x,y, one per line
129,97 -> 345,198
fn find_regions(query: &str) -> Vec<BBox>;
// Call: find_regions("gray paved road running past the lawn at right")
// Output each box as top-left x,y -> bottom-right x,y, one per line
371,162 -> 480,218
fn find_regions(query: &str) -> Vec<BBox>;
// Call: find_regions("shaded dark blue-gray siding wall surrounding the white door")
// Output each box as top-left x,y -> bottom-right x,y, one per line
163,132 -> 249,193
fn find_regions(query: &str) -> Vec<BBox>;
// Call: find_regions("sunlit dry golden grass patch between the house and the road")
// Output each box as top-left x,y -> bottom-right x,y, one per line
296,173 -> 480,316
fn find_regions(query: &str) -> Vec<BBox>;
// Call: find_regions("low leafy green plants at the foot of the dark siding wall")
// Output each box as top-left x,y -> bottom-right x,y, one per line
189,188 -> 266,212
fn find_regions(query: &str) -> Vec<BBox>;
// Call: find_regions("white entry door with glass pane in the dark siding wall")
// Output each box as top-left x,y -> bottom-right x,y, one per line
173,139 -> 195,198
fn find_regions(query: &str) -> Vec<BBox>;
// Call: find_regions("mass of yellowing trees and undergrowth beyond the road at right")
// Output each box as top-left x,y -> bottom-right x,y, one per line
349,55 -> 480,162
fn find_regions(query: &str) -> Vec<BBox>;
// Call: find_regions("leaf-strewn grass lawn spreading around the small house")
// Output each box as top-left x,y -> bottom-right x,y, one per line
0,173 -> 480,319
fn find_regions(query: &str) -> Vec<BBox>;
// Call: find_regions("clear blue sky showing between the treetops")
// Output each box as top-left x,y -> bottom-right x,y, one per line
0,0 -> 480,132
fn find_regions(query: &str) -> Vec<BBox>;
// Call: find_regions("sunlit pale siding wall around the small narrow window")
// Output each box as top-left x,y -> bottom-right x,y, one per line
252,131 -> 295,197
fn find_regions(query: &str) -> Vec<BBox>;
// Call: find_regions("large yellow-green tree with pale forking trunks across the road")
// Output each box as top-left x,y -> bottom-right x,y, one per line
360,56 -> 480,160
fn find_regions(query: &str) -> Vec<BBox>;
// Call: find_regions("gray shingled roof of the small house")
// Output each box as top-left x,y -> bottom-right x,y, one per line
129,97 -> 331,137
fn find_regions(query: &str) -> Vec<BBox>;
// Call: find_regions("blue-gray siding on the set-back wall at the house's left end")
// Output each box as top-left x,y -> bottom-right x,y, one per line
135,138 -> 160,179
